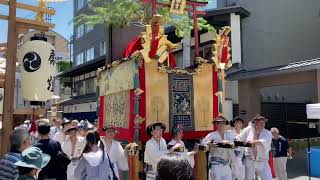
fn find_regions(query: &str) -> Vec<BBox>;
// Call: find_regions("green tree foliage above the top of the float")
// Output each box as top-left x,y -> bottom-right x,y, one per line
75,0 -> 215,37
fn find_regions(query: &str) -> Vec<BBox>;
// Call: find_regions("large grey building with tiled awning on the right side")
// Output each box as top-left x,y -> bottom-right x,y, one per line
228,0 -> 320,138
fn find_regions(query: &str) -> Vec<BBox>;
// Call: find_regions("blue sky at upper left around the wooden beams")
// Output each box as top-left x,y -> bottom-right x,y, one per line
0,0 -> 73,43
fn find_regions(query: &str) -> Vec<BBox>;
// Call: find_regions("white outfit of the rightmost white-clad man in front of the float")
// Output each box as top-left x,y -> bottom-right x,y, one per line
237,125 -> 272,180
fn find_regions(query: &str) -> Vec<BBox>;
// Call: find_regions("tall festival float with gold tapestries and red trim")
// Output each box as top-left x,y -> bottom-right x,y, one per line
98,1 -> 231,179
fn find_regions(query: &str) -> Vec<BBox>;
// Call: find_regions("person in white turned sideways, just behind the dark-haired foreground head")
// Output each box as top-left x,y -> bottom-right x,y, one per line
168,124 -> 199,168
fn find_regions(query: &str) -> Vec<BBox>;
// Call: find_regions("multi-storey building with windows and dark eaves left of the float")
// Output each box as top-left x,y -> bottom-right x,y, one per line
59,0 -> 141,122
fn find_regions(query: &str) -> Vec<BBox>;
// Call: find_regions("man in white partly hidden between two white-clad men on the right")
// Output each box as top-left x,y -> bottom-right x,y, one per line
230,116 -> 245,180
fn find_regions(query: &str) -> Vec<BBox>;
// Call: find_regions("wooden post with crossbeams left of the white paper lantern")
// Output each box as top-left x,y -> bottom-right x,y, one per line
0,0 -> 55,157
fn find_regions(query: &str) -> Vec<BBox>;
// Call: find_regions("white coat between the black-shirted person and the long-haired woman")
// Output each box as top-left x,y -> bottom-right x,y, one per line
61,136 -> 86,180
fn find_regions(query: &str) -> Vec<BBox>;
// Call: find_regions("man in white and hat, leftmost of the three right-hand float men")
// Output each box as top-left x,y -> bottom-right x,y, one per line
202,116 -> 234,180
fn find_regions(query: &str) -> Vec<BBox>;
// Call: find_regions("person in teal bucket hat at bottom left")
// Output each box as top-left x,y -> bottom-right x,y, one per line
15,147 -> 50,180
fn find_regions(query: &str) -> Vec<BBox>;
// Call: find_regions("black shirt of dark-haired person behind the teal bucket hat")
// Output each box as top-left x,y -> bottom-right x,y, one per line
34,139 -> 66,180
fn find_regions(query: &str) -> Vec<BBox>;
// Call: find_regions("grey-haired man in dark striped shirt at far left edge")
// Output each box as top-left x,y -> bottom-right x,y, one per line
0,128 -> 31,180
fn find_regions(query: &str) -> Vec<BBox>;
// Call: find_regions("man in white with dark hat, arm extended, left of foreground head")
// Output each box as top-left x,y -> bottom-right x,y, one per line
144,122 -> 182,180
